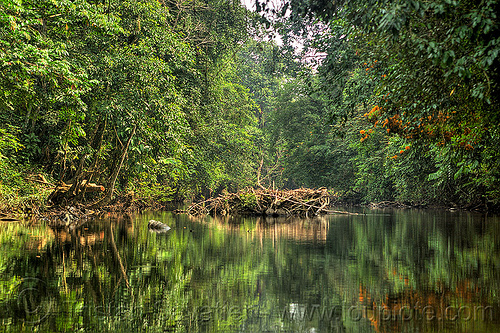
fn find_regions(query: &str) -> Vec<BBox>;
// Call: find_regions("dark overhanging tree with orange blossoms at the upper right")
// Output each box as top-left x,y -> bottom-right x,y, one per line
261,0 -> 499,205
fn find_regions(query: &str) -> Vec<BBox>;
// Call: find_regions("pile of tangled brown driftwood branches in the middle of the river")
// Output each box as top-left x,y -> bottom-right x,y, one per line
187,188 -> 347,217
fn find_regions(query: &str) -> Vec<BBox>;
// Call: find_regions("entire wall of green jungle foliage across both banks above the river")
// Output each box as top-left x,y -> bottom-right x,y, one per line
0,0 -> 500,208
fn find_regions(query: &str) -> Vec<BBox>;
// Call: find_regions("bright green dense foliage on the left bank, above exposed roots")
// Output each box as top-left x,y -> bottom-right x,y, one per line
0,0 -> 260,208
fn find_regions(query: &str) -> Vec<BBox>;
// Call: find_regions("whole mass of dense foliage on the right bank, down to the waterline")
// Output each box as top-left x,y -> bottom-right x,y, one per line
260,0 -> 500,207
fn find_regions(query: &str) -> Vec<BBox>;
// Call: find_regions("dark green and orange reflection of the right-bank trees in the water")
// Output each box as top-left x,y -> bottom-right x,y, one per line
342,212 -> 500,331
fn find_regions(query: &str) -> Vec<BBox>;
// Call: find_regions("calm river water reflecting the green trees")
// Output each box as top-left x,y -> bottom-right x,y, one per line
0,210 -> 500,332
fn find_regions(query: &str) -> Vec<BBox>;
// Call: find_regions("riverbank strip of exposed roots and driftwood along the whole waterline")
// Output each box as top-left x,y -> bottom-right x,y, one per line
0,173 -> 498,227
